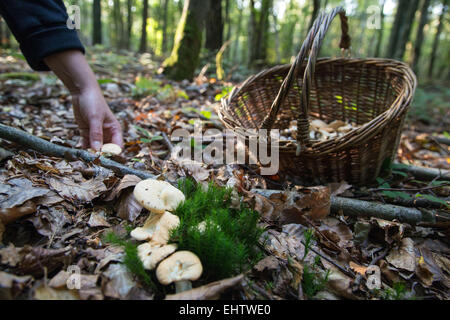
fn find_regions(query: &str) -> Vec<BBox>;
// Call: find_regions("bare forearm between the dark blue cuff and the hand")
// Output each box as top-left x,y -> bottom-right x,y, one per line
44,50 -> 100,95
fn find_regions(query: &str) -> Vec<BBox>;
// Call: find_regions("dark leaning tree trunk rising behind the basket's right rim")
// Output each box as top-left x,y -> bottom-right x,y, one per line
387,0 -> 419,60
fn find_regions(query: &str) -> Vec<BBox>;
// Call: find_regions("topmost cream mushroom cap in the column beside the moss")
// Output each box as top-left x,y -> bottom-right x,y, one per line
133,179 -> 185,214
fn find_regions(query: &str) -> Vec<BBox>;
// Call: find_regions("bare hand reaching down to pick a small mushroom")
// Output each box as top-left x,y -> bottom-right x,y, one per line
72,88 -> 123,151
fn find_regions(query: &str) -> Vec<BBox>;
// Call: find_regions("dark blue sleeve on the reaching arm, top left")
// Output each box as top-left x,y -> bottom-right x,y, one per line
0,0 -> 84,71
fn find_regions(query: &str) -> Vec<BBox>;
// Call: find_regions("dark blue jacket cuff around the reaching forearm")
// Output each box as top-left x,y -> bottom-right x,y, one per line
20,26 -> 85,71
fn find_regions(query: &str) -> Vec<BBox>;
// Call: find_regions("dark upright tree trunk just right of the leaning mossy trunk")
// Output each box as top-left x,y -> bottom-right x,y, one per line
205,0 -> 223,51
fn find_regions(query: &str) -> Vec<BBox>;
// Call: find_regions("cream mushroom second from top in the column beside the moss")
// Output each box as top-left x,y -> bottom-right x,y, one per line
130,211 -> 180,244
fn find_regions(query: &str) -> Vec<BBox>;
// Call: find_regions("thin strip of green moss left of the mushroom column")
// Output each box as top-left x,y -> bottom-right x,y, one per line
104,232 -> 156,289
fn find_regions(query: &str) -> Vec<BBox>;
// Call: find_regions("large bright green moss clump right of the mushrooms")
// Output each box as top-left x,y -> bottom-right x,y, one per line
171,179 -> 263,281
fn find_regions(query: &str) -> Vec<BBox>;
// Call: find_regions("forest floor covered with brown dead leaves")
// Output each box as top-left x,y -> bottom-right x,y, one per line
0,50 -> 450,299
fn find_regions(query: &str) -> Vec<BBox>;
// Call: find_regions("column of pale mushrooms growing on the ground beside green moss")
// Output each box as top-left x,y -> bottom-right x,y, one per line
127,179 -> 203,293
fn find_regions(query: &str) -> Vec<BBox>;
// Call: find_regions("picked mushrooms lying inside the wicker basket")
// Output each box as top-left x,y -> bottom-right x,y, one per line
281,119 -> 357,141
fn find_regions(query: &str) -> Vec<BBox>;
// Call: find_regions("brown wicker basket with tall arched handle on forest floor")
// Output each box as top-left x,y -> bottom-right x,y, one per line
218,7 -> 416,184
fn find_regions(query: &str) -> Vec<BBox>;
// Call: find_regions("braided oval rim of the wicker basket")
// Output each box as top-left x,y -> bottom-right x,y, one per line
218,57 -> 417,155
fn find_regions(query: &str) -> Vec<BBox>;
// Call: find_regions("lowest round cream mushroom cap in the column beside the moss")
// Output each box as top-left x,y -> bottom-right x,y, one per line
156,251 -> 203,285
